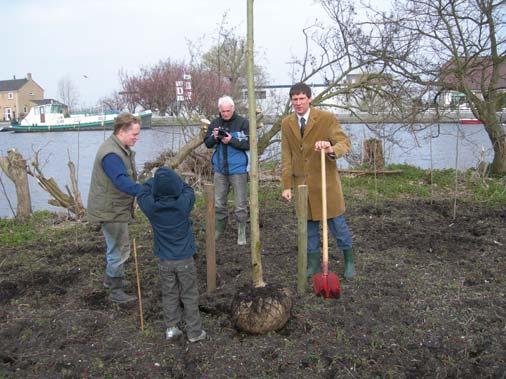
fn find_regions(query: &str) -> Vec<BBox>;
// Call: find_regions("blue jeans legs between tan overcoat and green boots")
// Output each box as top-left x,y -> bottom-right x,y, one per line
307,215 -> 352,253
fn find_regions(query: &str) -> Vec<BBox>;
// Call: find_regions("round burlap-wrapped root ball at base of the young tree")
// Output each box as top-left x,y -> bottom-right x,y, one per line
230,285 -> 292,334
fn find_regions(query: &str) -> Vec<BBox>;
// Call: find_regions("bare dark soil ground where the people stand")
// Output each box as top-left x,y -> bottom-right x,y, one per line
0,194 -> 506,378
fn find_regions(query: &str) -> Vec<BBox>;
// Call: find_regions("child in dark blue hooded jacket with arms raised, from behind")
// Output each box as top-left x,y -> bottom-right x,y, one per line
137,167 -> 206,342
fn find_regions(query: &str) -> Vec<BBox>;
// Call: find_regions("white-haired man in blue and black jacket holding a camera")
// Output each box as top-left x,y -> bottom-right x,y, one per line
204,96 -> 249,245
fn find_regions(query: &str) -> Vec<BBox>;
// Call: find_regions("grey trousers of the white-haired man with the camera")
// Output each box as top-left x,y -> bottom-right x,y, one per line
214,172 -> 248,223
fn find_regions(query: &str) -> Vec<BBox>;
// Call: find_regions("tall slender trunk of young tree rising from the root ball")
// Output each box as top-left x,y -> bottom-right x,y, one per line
246,0 -> 265,287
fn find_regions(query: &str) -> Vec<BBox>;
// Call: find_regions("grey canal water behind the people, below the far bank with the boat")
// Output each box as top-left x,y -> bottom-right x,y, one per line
0,124 -> 493,217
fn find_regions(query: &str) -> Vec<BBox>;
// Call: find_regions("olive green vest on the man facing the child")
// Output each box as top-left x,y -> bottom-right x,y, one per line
88,134 -> 137,222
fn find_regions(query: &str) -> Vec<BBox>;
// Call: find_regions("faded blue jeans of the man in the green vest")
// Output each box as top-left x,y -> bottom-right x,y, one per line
102,222 -> 130,278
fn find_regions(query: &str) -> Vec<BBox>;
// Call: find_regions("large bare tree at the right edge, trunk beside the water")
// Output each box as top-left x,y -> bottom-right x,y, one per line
362,0 -> 506,175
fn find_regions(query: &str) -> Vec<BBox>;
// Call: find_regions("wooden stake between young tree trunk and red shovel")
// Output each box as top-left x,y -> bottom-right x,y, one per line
297,185 -> 307,294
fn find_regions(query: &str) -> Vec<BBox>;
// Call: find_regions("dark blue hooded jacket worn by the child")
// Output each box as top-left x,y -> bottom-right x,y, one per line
137,167 -> 196,260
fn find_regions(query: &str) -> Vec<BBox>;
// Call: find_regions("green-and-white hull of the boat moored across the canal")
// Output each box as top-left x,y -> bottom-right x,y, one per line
9,112 -> 152,133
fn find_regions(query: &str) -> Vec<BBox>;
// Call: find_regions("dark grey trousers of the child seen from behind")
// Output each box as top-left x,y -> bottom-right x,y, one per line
158,258 -> 202,338
